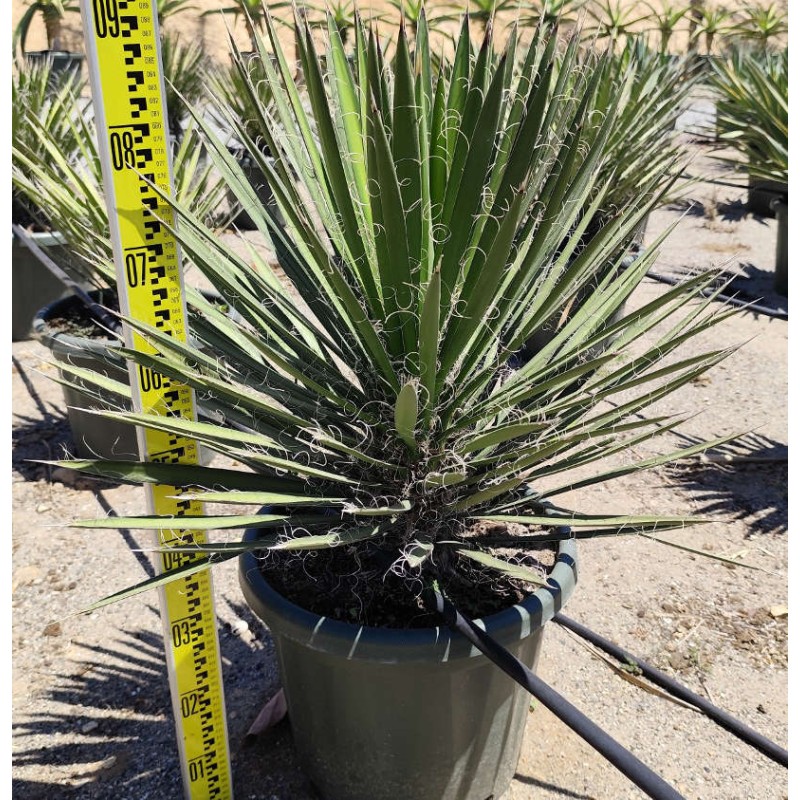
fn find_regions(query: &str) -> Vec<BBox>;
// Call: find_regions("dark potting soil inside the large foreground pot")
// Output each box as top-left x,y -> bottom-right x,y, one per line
259,528 -> 556,628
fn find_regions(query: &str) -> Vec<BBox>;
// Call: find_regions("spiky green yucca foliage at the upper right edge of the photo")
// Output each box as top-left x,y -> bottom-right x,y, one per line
711,48 -> 789,184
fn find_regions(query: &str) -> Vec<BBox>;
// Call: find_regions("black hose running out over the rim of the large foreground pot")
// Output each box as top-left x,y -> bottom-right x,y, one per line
428,591 -> 685,800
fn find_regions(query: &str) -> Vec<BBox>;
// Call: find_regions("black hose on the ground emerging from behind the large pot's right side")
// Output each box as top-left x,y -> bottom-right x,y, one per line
553,612 -> 789,767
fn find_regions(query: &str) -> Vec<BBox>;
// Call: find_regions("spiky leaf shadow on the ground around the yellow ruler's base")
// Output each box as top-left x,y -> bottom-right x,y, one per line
13,602 -> 315,800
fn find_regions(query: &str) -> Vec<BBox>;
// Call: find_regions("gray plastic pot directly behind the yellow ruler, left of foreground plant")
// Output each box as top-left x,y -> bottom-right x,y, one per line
33,290 -> 220,464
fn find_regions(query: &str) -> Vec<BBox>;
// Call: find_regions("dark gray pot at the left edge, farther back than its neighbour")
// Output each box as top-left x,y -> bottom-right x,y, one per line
11,232 -> 69,342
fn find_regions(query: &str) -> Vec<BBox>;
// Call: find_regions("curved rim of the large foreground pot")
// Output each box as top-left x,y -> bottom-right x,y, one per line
239,528 -> 577,662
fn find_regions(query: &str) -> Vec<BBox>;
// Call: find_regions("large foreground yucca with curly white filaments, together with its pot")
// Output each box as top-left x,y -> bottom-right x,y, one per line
61,10 -> 732,800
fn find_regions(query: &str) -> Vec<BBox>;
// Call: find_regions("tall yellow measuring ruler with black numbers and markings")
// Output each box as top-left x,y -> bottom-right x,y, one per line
81,0 -> 233,800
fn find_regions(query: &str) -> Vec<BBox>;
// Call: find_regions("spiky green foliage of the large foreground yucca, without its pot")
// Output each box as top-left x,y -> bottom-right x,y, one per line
65,12 -> 729,624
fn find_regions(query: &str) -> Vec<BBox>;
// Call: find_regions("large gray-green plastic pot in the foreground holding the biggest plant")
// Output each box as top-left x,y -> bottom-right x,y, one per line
239,530 -> 577,800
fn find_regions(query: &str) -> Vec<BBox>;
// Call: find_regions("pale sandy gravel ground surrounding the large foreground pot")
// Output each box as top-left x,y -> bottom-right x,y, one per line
11,70 -> 789,800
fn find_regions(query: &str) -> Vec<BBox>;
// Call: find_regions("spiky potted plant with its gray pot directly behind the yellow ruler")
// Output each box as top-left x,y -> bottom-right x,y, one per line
12,66 -> 231,458
